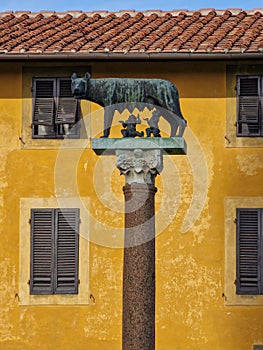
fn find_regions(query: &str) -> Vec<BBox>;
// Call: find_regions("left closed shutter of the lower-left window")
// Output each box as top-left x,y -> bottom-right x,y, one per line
30,209 -> 54,294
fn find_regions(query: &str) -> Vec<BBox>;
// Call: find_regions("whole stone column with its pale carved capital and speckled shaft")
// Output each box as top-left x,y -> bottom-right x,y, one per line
116,149 -> 162,350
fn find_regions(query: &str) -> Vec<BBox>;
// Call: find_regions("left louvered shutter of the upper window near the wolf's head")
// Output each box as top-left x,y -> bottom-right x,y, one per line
33,78 -> 55,125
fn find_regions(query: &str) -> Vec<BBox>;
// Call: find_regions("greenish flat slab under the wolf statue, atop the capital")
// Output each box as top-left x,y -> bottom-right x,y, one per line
91,137 -> 187,155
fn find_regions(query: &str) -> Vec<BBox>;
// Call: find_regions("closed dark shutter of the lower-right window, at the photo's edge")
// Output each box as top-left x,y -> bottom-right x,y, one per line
236,209 -> 262,294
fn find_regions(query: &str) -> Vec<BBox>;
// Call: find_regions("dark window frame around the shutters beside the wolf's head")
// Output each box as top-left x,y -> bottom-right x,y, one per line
31,76 -> 80,139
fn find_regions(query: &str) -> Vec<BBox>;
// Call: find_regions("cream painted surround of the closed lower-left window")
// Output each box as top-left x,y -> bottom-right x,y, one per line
18,197 -> 90,306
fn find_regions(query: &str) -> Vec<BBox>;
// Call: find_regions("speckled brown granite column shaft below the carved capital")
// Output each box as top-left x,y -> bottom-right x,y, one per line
122,183 -> 156,350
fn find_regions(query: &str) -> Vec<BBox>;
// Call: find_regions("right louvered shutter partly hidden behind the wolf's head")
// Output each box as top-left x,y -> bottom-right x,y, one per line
55,78 -> 78,124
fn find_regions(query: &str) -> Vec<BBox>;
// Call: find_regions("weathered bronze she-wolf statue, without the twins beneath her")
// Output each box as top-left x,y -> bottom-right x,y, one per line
71,73 -> 186,137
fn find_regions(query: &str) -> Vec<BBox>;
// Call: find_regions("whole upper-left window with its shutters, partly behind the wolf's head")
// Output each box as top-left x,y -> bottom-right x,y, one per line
32,78 -> 79,138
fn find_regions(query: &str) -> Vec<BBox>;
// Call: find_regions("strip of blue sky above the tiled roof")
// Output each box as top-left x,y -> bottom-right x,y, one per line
0,0 -> 263,12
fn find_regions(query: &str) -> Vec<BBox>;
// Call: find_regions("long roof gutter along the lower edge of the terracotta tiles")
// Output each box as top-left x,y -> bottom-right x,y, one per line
0,52 -> 263,61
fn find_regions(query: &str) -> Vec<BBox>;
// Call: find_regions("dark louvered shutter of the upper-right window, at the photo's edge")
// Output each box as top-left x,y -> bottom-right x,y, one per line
237,76 -> 261,136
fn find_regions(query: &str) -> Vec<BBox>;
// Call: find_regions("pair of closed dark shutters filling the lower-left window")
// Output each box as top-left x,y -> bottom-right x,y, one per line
30,208 -> 79,294
